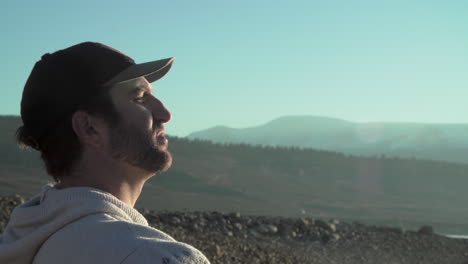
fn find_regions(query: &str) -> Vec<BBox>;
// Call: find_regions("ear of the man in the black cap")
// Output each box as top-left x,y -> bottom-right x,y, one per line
72,111 -> 106,148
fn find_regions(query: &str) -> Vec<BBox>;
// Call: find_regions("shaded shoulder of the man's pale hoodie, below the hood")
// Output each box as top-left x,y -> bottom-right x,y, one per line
35,213 -> 203,264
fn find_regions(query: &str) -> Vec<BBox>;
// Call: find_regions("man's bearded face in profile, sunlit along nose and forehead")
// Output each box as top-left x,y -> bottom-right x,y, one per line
105,77 -> 172,174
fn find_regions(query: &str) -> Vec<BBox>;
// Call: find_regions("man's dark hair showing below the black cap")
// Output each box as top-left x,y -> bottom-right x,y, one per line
16,89 -> 119,182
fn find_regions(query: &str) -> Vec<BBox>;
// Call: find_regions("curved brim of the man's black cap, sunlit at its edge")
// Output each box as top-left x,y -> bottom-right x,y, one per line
104,57 -> 175,86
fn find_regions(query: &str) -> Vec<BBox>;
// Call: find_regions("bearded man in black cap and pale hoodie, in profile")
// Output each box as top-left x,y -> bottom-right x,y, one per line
0,42 -> 209,264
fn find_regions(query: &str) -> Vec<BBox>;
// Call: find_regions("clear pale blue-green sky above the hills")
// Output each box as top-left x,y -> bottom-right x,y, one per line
0,0 -> 468,136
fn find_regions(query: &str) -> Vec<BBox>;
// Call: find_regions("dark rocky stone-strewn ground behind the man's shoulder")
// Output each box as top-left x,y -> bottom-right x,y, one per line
0,196 -> 468,264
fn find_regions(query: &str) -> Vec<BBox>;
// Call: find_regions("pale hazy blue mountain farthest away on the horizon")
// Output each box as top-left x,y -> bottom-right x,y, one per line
187,116 -> 468,163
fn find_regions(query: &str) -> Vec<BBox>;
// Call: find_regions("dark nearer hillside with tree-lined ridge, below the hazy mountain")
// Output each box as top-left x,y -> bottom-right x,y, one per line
0,116 -> 468,234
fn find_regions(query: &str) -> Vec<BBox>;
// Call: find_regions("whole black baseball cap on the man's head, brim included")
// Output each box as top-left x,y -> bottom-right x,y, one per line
17,42 -> 175,147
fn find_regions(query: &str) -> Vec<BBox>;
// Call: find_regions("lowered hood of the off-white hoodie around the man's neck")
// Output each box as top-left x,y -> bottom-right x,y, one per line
0,184 -> 148,264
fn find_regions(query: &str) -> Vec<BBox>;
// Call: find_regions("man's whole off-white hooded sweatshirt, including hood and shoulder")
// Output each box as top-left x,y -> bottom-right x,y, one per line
0,185 -> 209,264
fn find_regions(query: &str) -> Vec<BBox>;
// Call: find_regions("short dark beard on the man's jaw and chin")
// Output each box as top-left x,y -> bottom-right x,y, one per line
110,122 -> 172,174
